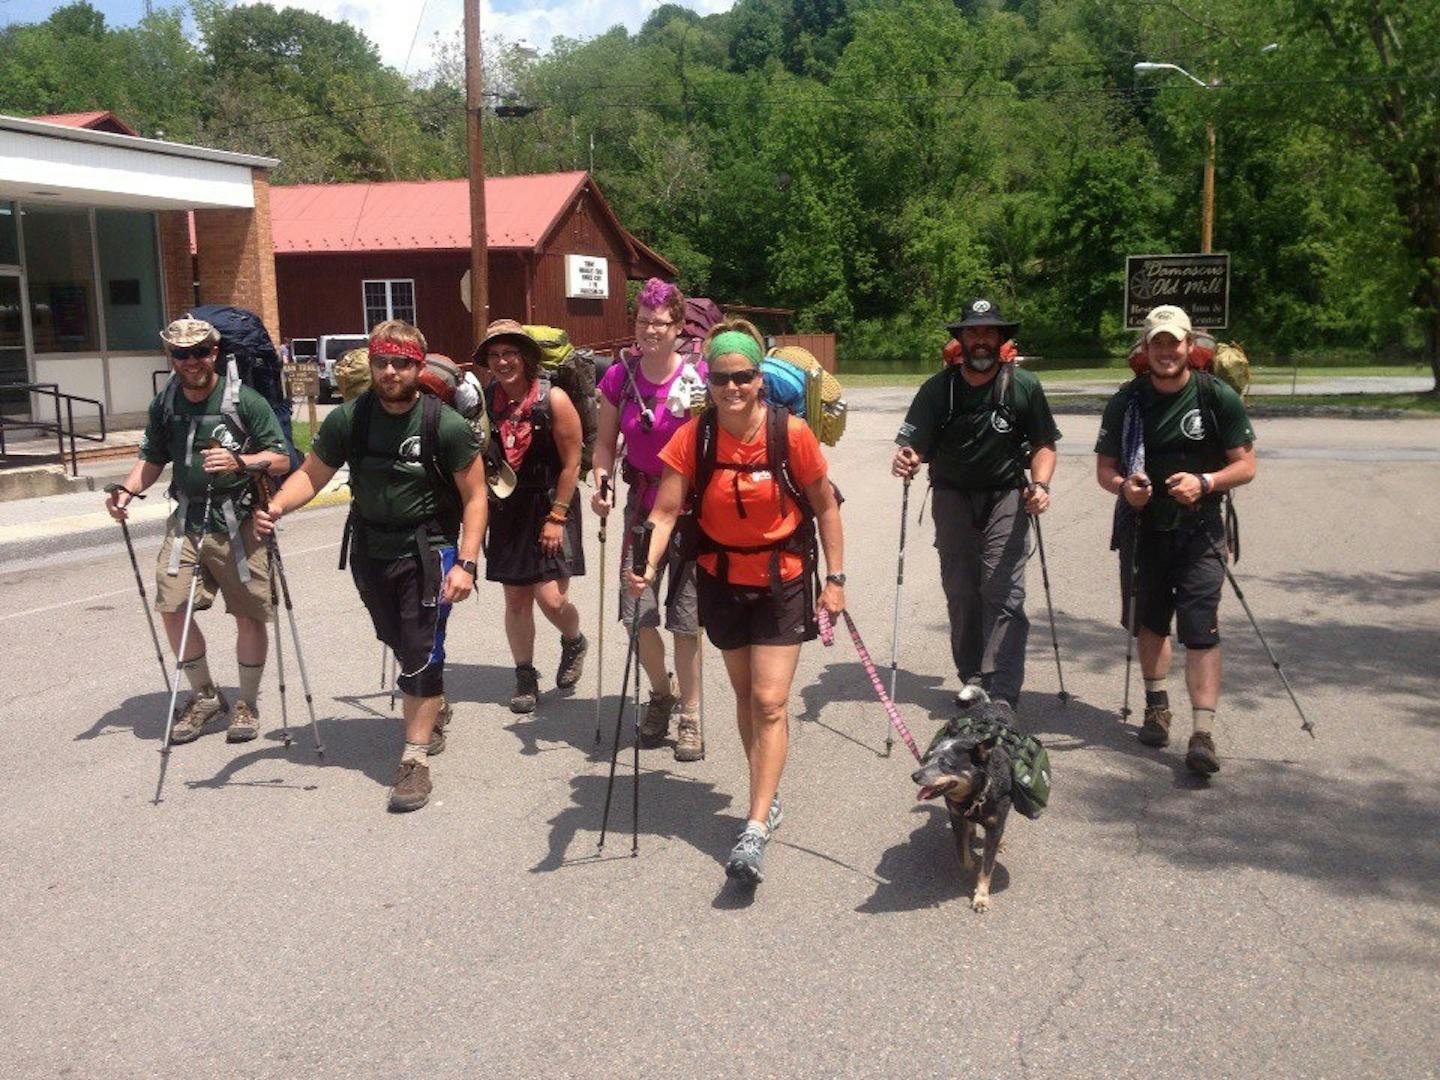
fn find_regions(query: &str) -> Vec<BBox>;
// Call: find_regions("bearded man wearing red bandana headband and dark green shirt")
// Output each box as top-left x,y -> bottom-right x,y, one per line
255,320 -> 487,811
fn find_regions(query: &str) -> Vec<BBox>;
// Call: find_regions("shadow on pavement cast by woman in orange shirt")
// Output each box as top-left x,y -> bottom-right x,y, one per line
530,771 -> 744,874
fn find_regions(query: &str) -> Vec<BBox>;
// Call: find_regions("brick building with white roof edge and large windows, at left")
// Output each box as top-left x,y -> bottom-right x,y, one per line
0,112 -> 279,415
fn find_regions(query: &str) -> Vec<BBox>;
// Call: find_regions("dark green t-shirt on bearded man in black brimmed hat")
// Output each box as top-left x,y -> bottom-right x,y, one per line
896,366 -> 1060,490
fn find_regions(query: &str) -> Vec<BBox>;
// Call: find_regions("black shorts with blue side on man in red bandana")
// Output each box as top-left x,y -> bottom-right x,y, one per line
350,547 -> 455,697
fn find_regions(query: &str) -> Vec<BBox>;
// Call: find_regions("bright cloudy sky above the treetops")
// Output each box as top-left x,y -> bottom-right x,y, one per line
0,0 -> 734,73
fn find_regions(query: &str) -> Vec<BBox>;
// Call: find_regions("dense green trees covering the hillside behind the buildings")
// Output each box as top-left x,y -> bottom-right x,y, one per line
0,0 -> 1440,380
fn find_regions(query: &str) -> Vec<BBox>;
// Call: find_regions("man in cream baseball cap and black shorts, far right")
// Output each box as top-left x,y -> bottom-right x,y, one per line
1094,305 -> 1256,775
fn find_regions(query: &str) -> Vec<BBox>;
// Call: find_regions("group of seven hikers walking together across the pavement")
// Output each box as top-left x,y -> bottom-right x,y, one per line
107,279 -> 1254,883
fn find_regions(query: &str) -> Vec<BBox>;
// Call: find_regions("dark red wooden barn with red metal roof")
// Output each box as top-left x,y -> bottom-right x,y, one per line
271,171 -> 675,359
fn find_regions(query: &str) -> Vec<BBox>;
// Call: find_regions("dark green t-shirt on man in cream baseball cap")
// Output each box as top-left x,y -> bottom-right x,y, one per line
1094,373 -> 1256,530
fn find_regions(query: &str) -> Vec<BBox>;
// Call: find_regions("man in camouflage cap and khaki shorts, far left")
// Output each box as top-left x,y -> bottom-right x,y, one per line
105,317 -> 289,743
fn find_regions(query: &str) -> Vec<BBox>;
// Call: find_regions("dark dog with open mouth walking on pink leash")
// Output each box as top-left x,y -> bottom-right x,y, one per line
910,688 -> 1015,912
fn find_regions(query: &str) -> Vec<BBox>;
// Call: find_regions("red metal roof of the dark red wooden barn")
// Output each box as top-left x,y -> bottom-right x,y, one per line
271,173 -> 586,255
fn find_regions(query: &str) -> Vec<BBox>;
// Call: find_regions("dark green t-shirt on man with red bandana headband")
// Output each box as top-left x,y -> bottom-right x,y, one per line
311,395 -> 480,559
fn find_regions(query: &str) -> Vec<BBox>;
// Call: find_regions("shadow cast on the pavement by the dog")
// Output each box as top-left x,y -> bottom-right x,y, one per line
855,802 -> 1009,914
